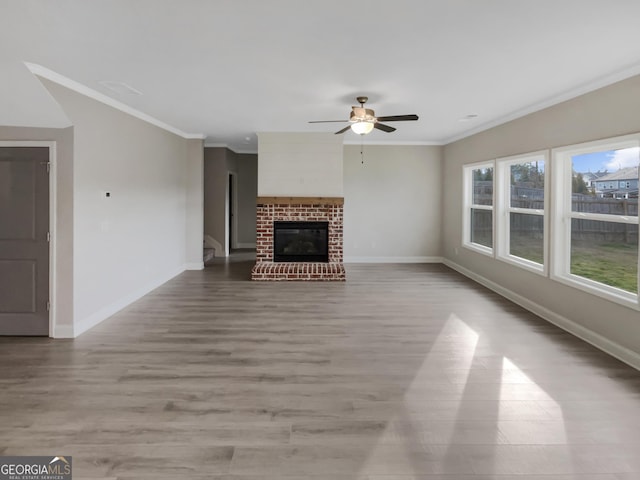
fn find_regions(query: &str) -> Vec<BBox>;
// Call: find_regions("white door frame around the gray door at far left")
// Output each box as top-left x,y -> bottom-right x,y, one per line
0,140 -> 57,338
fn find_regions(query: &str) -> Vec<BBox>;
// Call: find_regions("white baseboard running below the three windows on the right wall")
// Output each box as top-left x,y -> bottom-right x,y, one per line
442,259 -> 640,370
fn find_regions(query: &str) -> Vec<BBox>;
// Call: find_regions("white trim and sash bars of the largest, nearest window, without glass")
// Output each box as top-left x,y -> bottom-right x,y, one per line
549,134 -> 640,310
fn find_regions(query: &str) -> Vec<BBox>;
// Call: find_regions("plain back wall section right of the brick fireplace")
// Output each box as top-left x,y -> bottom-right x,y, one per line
344,145 -> 442,263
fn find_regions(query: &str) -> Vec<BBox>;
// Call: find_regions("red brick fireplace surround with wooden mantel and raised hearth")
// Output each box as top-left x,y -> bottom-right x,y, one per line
251,197 -> 346,281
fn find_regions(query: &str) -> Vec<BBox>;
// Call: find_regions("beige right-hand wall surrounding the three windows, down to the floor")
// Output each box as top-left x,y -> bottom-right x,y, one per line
442,76 -> 640,368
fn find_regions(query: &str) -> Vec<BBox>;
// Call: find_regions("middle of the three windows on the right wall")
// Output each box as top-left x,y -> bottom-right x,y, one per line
496,152 -> 547,273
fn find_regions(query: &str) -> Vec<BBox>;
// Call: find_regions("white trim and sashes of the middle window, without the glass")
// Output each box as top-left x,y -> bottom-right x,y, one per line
494,150 -> 550,276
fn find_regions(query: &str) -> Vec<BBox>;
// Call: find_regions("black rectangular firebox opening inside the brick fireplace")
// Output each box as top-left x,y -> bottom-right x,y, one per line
273,222 -> 329,263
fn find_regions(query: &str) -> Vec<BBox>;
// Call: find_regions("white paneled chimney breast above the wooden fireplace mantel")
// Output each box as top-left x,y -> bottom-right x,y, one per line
258,133 -> 343,197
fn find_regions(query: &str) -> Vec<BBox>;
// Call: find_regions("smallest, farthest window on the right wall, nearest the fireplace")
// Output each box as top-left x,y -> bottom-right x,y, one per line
463,162 -> 493,255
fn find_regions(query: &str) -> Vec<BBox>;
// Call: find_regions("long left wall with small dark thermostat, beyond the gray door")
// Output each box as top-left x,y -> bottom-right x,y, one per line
41,79 -> 201,335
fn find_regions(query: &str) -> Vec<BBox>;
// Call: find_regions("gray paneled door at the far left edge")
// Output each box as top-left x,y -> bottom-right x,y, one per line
0,147 -> 49,335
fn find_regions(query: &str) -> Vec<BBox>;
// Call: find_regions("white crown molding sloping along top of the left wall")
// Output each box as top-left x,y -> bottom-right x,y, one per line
24,62 -> 205,140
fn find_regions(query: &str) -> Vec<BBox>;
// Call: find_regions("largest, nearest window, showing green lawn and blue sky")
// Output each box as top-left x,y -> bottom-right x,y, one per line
553,135 -> 640,306
